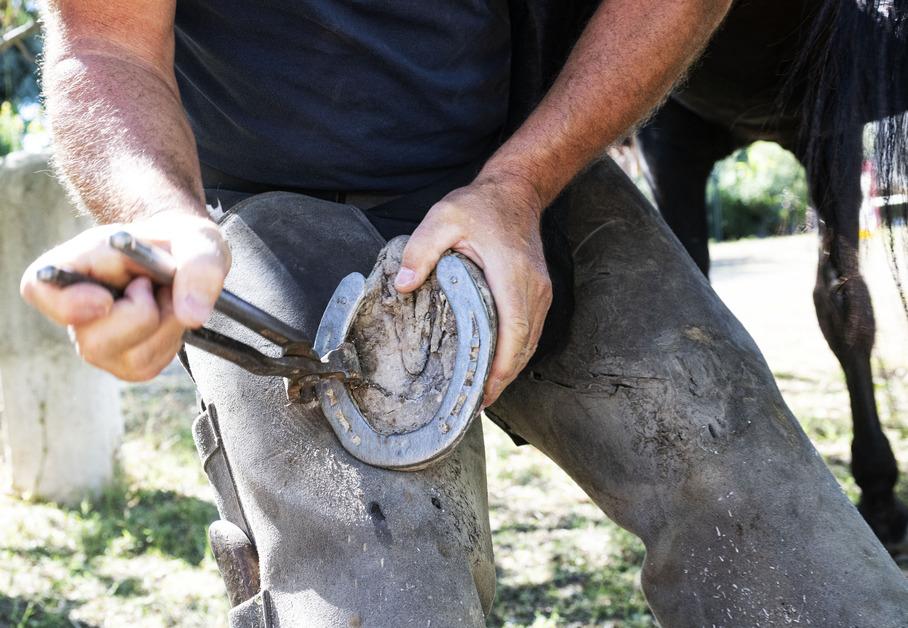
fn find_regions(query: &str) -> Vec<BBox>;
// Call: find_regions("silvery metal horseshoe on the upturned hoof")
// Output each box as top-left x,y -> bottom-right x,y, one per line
314,254 -> 495,471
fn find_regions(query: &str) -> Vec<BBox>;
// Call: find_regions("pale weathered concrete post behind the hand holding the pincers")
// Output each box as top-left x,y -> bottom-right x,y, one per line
0,153 -> 123,503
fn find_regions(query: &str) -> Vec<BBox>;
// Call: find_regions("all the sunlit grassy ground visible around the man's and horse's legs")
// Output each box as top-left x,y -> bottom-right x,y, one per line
0,235 -> 908,628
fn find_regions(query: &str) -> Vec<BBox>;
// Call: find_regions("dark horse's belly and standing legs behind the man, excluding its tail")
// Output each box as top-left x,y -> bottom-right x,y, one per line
637,0 -> 908,550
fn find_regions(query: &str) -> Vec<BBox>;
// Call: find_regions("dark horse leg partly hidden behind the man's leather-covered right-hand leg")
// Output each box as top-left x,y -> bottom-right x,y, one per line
637,100 -> 735,276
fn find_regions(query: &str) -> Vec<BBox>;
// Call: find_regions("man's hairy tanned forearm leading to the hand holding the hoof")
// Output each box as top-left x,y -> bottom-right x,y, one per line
480,0 -> 731,208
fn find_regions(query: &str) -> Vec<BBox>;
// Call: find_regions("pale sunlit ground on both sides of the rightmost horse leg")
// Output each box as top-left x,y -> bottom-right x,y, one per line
711,232 -> 908,474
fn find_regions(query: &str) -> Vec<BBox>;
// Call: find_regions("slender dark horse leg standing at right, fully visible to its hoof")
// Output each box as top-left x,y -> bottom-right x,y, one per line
809,133 -> 908,550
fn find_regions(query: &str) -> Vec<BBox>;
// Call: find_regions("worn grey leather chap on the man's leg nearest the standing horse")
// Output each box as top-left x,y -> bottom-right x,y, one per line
490,161 -> 908,626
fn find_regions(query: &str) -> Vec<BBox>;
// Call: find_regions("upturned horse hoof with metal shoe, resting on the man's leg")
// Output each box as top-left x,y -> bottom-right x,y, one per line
316,237 -> 495,470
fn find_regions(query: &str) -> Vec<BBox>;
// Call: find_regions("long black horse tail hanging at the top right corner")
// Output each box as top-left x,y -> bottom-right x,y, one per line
786,0 -> 908,314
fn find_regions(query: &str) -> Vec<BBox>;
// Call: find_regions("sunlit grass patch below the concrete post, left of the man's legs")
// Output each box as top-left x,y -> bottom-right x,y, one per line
0,371 -> 227,628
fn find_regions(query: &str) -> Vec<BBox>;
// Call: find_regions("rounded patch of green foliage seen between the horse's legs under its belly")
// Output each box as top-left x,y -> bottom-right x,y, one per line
707,142 -> 807,239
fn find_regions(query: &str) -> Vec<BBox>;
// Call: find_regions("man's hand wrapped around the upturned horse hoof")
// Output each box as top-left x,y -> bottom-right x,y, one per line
395,176 -> 552,406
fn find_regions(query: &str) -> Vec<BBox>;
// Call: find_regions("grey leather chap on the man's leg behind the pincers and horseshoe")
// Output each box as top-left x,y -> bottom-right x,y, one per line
188,195 -> 494,626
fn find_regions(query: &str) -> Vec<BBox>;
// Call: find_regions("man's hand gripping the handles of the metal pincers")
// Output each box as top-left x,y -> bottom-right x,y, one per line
20,211 -> 230,381
